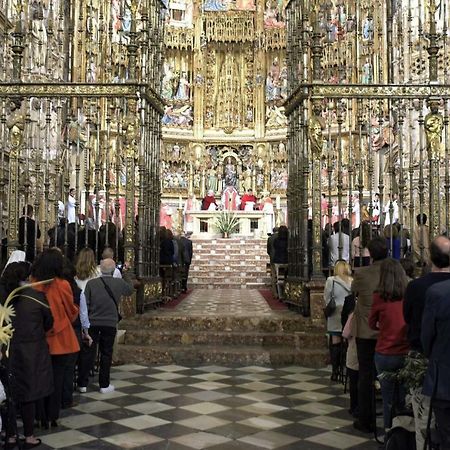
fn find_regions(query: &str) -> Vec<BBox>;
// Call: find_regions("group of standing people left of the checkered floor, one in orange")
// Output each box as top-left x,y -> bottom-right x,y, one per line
0,247 -> 133,449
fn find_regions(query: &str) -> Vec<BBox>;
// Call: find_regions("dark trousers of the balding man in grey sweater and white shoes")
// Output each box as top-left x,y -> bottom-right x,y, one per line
78,326 -> 117,388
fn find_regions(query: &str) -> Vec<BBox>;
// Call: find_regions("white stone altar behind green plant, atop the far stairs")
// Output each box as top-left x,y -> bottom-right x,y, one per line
189,211 -> 273,238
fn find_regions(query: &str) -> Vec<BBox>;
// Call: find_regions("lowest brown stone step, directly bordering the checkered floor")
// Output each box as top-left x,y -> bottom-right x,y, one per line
117,344 -> 328,367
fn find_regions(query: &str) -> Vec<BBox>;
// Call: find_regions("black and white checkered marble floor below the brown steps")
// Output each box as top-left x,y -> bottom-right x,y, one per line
37,365 -> 377,450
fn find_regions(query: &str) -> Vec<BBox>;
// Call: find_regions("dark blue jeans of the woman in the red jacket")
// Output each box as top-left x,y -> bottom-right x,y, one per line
375,353 -> 406,429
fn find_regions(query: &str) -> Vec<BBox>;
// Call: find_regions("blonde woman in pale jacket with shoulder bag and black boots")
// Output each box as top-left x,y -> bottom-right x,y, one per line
323,259 -> 352,381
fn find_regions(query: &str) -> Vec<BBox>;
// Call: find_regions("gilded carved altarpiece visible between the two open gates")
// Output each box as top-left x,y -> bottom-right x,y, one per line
161,0 -> 288,208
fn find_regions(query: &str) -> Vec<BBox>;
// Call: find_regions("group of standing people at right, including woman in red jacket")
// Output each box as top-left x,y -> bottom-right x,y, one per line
324,230 -> 450,450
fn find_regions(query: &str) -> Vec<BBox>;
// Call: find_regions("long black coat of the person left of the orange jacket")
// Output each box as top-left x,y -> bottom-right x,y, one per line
0,287 -> 53,402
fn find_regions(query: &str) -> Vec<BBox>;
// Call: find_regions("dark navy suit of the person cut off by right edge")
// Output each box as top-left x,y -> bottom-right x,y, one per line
421,254 -> 450,450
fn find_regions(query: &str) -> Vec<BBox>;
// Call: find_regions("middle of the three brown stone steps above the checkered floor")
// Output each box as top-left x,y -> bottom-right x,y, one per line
124,329 -> 326,349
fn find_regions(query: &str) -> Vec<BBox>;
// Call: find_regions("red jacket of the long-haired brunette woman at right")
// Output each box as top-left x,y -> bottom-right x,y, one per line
369,292 -> 409,355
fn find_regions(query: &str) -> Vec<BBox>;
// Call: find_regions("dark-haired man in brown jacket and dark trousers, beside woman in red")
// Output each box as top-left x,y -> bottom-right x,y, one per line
352,237 -> 388,433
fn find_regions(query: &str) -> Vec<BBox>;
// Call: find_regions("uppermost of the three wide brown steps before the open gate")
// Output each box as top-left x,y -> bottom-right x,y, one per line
120,311 -> 314,333
